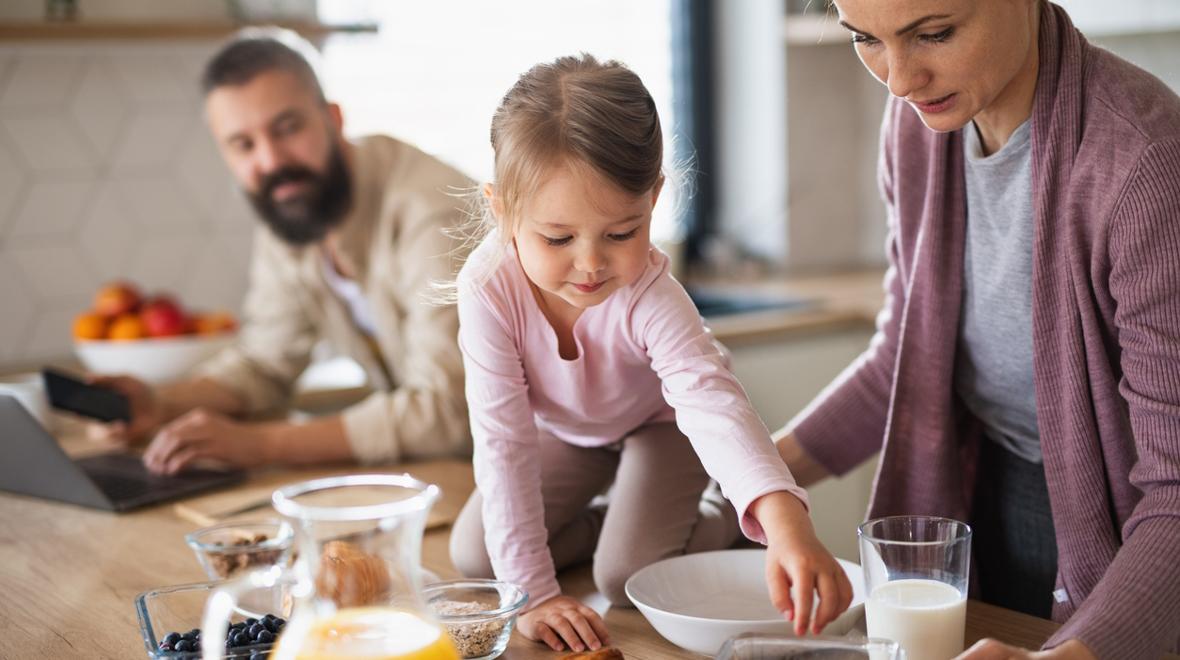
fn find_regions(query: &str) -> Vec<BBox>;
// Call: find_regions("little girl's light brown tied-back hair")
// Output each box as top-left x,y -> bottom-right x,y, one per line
481,53 -> 663,241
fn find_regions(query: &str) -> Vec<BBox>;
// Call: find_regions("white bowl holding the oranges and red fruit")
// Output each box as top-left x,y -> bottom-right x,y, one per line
74,333 -> 235,383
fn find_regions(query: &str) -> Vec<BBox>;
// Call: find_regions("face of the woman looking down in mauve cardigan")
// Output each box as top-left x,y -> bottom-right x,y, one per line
834,0 -> 1038,131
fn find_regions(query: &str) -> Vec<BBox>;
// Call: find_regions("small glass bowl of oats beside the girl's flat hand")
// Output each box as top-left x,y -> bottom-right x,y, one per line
422,580 -> 529,660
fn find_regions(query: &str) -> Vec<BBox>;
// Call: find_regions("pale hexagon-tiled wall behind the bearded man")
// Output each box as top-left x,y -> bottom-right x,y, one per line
0,41 -> 256,368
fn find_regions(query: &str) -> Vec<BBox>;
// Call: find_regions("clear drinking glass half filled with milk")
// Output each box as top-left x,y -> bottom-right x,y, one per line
857,516 -> 971,660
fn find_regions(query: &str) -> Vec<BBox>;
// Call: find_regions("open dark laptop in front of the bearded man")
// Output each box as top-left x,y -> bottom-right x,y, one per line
0,394 -> 245,511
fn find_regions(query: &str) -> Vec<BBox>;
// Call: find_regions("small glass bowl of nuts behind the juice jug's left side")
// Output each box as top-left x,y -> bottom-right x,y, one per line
184,518 -> 294,580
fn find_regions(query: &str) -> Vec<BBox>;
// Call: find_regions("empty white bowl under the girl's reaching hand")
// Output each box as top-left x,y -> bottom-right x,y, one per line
627,549 -> 865,656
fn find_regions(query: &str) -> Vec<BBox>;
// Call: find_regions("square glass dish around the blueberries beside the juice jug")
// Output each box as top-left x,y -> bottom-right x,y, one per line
136,582 -> 290,660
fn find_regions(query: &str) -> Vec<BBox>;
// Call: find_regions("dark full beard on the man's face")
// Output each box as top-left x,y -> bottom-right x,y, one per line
247,146 -> 353,246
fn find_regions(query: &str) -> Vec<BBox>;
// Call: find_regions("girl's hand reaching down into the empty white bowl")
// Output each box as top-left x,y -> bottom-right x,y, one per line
750,491 -> 852,635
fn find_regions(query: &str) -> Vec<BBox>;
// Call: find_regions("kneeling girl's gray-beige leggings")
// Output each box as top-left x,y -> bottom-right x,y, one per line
451,423 -> 741,606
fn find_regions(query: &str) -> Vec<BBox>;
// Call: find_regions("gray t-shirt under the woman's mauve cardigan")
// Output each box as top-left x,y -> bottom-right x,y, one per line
955,122 -> 1041,463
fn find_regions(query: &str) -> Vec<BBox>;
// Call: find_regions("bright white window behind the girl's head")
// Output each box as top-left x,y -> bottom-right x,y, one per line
319,0 -> 677,241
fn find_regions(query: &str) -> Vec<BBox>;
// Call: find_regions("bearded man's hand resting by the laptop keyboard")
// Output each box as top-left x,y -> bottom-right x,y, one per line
144,409 -> 271,475
